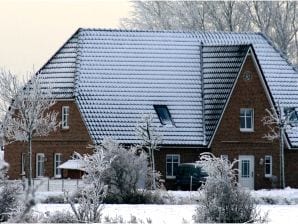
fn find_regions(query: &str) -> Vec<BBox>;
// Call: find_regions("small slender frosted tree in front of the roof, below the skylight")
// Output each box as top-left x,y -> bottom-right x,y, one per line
136,114 -> 162,190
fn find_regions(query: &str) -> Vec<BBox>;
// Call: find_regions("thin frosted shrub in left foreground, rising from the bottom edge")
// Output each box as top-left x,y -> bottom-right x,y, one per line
66,144 -> 113,223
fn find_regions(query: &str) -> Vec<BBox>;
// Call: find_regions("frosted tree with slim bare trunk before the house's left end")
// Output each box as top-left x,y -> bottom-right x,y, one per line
0,71 -> 59,187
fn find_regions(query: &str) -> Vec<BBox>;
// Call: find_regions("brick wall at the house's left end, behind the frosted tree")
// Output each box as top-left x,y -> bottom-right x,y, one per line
5,101 -> 92,179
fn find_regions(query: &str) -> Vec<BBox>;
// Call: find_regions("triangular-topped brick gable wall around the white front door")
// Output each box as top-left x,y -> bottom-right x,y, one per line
211,56 -> 279,189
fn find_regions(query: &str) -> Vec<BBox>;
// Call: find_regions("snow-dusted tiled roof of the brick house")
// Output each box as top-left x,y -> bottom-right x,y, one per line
37,29 -> 298,146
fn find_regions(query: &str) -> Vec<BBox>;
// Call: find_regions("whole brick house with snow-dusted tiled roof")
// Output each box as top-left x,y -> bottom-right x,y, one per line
5,29 -> 298,189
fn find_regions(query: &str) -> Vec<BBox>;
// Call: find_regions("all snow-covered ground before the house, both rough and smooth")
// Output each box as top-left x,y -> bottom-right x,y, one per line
34,188 -> 298,224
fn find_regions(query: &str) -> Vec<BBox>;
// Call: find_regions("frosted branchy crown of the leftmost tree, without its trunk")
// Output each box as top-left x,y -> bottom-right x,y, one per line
1,73 -> 59,142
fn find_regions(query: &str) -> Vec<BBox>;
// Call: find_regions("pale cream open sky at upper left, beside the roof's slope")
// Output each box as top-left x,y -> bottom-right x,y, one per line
0,0 -> 131,76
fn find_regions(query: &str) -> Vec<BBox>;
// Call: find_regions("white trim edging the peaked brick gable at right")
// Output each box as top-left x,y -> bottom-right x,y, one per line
208,47 -> 276,148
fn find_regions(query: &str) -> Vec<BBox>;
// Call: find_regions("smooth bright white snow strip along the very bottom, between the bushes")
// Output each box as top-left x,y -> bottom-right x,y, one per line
34,204 -> 298,224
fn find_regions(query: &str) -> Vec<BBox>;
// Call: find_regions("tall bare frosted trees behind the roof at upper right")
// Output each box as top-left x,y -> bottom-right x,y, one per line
121,1 -> 298,65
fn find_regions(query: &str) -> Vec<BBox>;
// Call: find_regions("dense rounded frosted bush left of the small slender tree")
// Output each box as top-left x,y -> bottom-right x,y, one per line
101,139 -> 148,203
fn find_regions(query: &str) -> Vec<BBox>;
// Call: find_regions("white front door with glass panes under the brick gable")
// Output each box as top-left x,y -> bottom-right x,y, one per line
239,155 -> 255,190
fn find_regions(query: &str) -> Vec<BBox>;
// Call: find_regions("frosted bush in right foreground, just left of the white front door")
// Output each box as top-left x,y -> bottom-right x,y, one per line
193,153 -> 264,223
